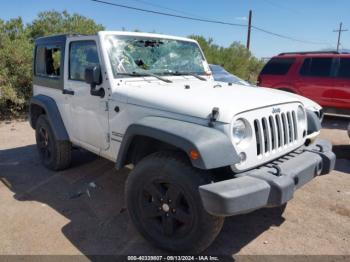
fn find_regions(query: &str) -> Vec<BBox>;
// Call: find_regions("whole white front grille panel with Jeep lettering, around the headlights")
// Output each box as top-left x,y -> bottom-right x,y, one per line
232,102 -> 307,172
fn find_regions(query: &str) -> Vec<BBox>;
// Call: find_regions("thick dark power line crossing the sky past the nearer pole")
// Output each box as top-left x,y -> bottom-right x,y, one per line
90,0 -> 329,45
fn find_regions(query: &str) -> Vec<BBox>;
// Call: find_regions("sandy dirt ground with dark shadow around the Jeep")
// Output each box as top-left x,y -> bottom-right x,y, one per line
0,117 -> 350,257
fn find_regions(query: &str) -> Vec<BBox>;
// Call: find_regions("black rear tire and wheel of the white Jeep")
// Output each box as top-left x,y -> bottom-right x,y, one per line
35,115 -> 72,171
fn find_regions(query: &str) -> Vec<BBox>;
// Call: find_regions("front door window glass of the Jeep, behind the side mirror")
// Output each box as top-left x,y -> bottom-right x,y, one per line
69,41 -> 99,81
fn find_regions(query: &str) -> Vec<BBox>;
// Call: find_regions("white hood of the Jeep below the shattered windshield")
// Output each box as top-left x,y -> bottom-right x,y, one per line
125,79 -> 300,123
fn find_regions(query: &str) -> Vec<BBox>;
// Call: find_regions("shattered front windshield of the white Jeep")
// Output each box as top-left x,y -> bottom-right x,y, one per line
105,35 -> 207,78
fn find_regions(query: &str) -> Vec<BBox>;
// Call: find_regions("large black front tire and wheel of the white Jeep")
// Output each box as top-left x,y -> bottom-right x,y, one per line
125,152 -> 224,254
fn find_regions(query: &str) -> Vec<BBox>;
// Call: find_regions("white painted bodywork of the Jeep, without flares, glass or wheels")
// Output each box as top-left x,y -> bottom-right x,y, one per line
34,31 -> 320,170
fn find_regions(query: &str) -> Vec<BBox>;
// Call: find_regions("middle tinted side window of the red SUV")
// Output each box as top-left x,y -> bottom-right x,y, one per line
300,57 -> 333,77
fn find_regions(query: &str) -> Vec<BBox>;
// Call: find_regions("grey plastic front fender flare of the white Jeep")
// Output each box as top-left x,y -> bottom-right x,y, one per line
116,117 -> 240,170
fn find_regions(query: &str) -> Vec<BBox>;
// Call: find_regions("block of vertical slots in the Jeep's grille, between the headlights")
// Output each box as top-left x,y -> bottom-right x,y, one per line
254,110 -> 298,156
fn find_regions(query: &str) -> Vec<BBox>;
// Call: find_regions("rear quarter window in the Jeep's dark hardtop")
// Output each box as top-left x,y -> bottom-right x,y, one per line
35,46 -> 61,77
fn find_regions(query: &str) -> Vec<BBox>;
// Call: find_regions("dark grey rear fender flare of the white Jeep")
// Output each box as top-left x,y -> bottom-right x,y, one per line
29,95 -> 69,141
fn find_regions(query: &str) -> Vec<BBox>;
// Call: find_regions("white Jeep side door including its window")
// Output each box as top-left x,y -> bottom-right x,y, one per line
65,40 -> 109,153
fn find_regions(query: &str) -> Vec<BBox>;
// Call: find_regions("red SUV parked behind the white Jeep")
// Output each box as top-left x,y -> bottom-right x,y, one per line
258,52 -> 350,116
